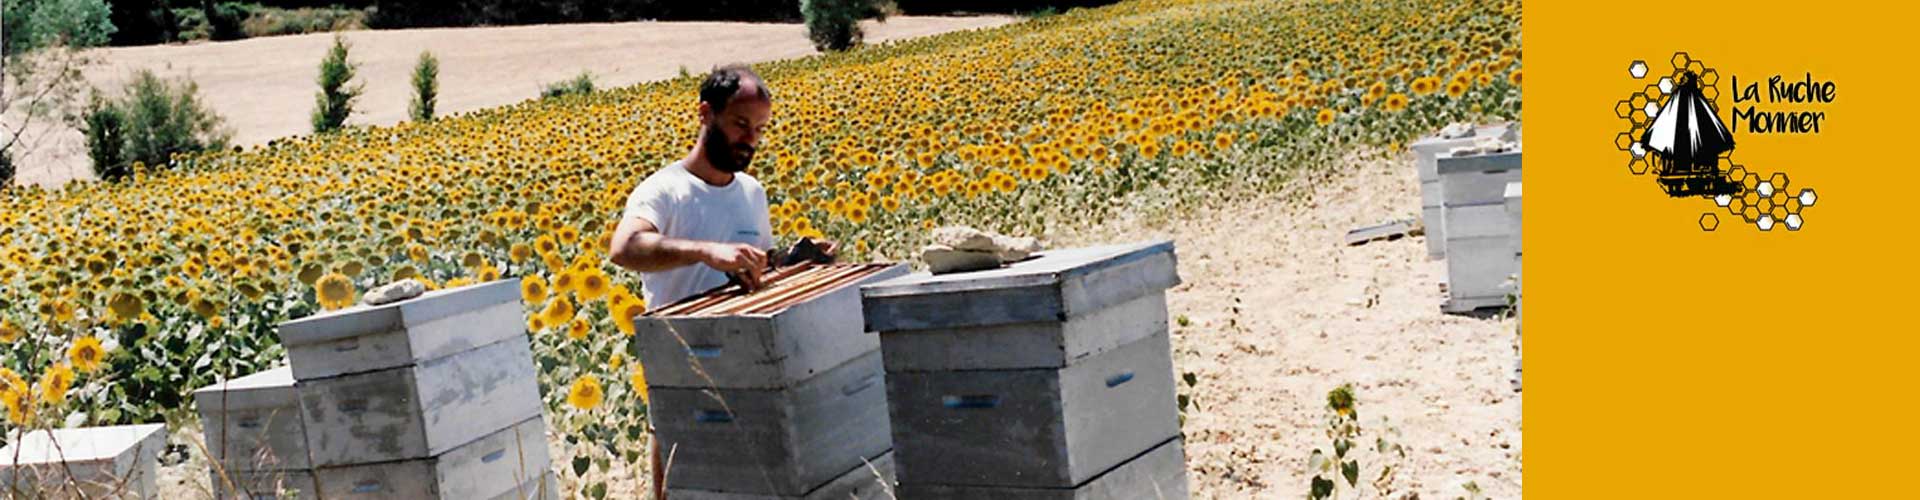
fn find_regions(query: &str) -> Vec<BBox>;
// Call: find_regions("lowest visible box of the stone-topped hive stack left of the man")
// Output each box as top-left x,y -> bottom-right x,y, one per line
315,417 -> 553,500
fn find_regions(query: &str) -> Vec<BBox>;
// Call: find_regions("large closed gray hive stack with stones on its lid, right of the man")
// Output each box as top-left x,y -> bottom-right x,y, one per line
862,242 -> 1187,498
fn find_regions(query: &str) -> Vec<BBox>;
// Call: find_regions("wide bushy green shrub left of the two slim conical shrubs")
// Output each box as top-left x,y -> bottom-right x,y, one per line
83,71 -> 228,181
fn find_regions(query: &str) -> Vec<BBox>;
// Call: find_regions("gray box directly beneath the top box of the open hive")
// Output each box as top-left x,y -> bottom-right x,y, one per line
647,350 -> 891,496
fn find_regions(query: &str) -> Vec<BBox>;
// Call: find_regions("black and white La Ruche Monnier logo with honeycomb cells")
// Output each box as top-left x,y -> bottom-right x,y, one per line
1613,52 -> 1836,231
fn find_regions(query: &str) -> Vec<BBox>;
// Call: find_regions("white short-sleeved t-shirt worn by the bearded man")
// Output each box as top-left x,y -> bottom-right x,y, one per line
624,162 -> 774,310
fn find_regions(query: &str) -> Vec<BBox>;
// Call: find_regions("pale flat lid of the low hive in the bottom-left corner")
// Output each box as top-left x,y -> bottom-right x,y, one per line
0,423 -> 167,465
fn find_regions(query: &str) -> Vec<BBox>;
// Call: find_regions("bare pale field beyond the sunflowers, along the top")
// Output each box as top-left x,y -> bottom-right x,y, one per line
3,15 -> 1020,187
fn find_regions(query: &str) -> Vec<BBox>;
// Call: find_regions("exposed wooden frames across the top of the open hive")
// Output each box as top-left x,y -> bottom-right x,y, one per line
647,262 -> 899,317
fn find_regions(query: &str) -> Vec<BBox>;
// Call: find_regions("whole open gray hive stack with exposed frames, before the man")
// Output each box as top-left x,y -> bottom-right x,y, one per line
630,263 -> 906,500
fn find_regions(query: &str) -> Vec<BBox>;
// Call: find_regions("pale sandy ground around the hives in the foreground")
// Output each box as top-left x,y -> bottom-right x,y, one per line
142,154 -> 1523,498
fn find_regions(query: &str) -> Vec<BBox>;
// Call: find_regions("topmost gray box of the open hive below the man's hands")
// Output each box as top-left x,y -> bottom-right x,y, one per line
628,263 -> 906,388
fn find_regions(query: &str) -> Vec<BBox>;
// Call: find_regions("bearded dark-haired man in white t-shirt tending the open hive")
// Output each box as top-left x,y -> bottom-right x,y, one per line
609,65 -> 802,308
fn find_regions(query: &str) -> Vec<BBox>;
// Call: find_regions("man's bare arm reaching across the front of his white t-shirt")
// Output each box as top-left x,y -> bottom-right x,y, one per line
607,217 -> 766,287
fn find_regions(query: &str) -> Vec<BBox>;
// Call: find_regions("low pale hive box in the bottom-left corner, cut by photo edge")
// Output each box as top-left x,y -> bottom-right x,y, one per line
0,423 -> 167,498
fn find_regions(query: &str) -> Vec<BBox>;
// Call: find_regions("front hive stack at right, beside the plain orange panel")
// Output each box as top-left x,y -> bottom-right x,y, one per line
1436,144 -> 1521,312
